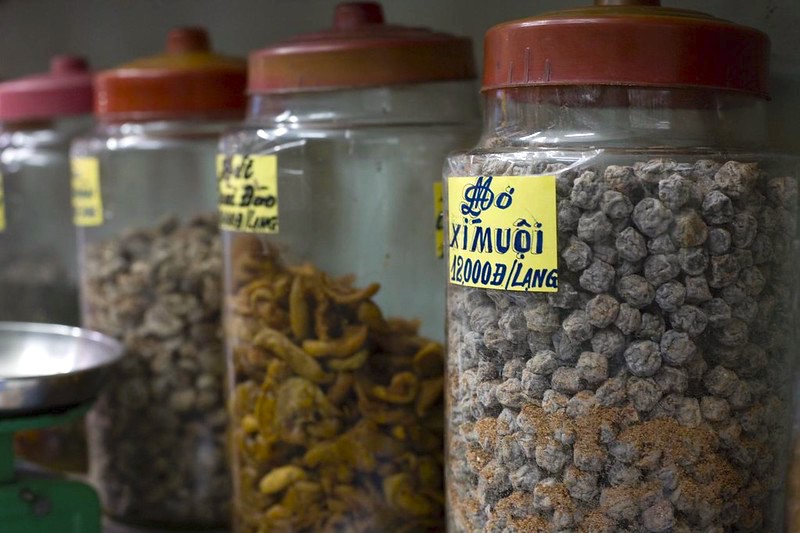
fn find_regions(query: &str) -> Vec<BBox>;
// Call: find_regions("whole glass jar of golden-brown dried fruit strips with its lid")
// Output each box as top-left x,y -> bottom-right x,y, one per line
219,3 -> 477,533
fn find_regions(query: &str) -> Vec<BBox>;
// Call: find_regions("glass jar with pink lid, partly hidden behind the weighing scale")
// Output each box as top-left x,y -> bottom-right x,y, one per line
0,56 -> 92,472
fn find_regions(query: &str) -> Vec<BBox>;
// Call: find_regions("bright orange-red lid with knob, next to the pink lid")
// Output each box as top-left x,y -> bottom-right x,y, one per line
95,28 -> 246,120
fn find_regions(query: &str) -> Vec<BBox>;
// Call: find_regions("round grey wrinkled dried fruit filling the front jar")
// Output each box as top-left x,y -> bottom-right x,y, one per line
448,155 -> 797,532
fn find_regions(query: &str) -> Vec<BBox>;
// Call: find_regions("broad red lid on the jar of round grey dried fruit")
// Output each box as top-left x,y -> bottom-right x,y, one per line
482,0 -> 770,97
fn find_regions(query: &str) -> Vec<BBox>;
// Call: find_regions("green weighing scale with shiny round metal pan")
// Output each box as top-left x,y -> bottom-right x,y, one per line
0,322 -> 122,533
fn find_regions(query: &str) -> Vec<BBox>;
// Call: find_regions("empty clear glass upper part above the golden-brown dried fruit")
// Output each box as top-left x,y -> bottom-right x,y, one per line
227,82 -> 477,341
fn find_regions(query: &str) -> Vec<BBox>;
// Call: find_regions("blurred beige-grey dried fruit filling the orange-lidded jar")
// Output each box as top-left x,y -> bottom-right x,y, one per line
82,216 -> 231,527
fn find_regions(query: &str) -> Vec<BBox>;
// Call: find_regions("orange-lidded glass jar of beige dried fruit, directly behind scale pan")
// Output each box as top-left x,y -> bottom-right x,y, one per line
72,29 -> 245,531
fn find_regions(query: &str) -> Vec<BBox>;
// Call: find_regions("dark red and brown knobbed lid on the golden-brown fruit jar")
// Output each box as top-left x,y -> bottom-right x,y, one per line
248,2 -> 475,93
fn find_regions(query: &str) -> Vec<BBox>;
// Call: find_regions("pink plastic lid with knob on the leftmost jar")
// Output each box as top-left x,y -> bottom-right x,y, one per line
0,56 -> 92,122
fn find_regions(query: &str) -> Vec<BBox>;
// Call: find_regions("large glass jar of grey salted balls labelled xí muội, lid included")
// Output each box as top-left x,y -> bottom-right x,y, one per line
445,2 -> 798,532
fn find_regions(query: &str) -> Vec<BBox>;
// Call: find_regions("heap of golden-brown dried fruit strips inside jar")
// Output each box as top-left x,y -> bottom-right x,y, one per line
227,236 -> 444,533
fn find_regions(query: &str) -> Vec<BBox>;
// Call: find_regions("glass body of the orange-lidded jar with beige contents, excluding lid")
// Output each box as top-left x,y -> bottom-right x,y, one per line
72,120 -> 229,526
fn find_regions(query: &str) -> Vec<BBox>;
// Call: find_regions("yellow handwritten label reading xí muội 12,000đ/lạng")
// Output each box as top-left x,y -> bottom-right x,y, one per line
447,176 -> 558,292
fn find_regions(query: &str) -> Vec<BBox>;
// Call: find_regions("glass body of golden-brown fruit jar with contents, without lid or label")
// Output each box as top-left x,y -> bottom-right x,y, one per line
221,82 -> 476,531
